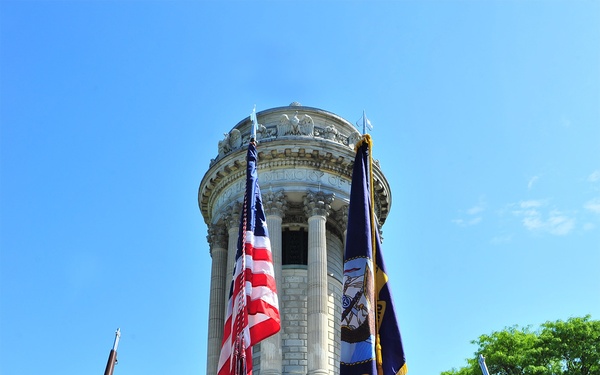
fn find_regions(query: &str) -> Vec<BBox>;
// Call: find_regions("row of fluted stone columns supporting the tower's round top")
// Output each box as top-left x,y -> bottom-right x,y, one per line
207,191 -> 345,375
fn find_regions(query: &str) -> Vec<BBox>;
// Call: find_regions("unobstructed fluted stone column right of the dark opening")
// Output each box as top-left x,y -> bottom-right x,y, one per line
304,192 -> 333,375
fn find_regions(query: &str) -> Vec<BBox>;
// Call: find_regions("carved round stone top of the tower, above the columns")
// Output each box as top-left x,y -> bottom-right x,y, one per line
198,103 -> 391,229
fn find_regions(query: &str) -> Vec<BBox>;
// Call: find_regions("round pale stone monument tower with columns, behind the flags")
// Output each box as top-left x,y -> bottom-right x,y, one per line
198,102 -> 392,375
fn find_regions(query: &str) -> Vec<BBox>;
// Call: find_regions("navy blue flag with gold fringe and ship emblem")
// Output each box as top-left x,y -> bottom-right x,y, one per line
340,134 -> 408,375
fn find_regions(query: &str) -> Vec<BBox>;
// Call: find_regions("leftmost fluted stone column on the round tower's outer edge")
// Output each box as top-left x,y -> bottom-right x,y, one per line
206,224 -> 227,374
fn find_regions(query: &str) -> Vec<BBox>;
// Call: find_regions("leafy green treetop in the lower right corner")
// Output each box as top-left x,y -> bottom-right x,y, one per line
441,315 -> 600,375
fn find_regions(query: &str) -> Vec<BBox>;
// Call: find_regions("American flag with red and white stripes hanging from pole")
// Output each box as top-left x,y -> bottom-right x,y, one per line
218,142 -> 281,375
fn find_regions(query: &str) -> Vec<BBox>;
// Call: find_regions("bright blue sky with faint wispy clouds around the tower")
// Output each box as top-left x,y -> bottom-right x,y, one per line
0,0 -> 600,375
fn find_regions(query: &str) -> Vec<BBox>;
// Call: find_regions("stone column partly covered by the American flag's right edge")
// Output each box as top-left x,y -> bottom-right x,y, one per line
260,190 -> 287,375
